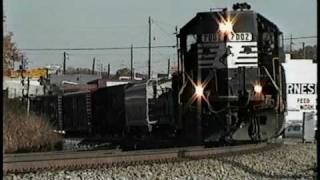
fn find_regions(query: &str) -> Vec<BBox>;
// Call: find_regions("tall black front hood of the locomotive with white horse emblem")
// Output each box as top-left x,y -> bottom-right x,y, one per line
181,11 -> 259,104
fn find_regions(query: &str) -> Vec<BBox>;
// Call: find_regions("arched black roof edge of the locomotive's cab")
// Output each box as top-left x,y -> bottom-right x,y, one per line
179,10 -> 280,35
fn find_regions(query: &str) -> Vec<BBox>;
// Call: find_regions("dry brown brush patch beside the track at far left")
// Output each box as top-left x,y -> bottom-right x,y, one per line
3,98 -> 62,153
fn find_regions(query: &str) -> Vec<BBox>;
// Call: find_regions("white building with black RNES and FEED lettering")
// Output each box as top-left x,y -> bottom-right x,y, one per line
283,55 -> 317,124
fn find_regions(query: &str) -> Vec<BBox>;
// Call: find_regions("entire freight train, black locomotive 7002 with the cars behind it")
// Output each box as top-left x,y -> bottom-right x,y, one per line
31,4 -> 286,148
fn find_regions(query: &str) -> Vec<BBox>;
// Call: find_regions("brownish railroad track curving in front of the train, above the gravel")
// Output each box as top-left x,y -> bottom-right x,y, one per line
3,143 -> 281,174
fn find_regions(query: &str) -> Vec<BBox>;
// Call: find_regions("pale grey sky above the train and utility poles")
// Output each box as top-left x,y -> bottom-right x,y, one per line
3,0 -> 317,73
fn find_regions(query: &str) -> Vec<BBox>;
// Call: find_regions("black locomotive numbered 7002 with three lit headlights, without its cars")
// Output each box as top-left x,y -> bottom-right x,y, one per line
173,5 -> 285,144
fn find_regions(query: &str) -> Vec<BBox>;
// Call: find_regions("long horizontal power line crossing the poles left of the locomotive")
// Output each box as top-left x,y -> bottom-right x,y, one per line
20,45 -> 176,51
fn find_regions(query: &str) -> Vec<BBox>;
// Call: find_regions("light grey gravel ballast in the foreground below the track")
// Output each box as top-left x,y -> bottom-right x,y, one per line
4,143 -> 316,180
